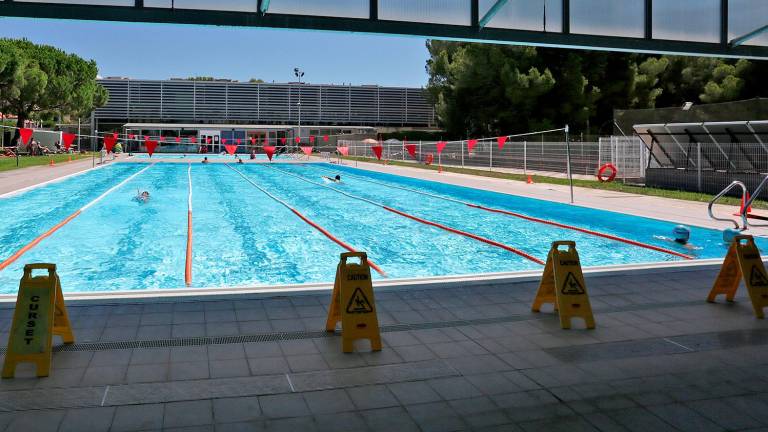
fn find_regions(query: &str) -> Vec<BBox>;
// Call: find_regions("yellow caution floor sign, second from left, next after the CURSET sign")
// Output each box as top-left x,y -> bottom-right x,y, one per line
325,252 -> 381,352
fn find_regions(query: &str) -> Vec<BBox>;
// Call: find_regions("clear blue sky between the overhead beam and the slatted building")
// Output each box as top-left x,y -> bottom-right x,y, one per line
0,18 -> 428,87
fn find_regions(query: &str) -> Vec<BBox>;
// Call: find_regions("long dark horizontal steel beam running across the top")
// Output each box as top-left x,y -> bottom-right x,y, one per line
0,0 -> 768,59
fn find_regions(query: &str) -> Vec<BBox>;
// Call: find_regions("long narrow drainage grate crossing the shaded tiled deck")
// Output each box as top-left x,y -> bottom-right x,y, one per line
0,301 -> 702,354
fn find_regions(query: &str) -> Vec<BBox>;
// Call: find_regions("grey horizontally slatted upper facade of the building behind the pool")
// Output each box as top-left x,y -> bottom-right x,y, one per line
94,79 -> 435,127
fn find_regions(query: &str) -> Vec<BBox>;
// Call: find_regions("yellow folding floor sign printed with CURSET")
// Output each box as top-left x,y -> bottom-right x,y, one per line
2,264 -> 75,378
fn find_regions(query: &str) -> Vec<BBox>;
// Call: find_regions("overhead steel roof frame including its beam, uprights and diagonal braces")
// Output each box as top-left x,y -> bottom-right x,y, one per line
0,0 -> 768,59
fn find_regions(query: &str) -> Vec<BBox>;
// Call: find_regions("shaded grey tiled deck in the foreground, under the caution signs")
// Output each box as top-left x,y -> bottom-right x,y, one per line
0,270 -> 768,432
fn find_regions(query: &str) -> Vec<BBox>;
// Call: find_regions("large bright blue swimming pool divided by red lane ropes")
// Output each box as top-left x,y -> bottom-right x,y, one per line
0,162 -> 756,294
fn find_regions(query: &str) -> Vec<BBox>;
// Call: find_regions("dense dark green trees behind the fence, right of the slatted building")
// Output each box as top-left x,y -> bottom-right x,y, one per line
427,40 -> 768,138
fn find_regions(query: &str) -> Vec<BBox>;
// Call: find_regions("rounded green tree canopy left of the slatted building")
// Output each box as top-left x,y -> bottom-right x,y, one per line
0,39 -> 108,132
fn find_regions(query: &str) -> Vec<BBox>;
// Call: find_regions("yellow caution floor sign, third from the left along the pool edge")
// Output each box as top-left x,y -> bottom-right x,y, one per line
531,241 -> 595,329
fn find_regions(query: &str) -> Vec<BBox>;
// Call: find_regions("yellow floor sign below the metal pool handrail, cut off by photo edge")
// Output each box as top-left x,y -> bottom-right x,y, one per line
707,235 -> 768,318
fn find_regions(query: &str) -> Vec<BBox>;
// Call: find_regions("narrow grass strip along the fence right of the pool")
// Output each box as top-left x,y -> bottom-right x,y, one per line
344,156 -> 768,209
